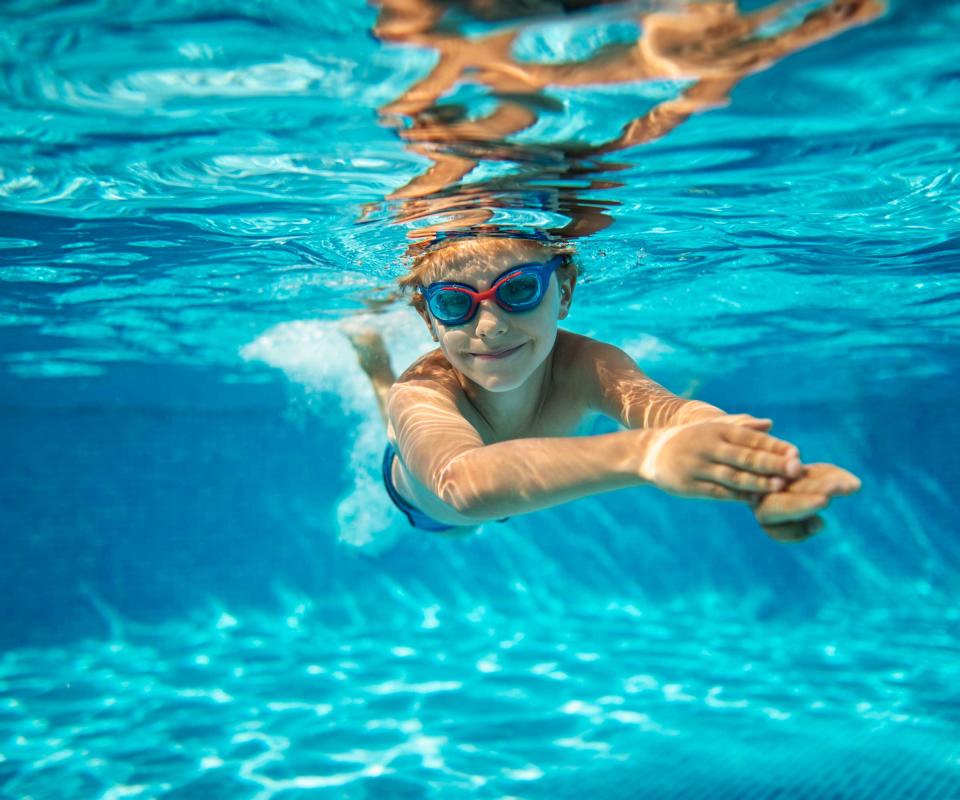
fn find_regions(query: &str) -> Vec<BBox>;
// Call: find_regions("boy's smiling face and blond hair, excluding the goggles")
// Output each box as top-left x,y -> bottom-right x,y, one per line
421,239 -> 576,392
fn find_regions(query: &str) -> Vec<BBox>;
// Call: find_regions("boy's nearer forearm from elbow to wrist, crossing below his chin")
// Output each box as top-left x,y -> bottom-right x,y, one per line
441,430 -> 657,520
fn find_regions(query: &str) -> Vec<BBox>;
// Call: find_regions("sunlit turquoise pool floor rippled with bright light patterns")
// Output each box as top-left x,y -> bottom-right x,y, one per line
0,604 -> 960,800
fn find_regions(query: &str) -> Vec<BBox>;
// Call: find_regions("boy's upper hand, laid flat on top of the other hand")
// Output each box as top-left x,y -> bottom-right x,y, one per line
639,414 -> 803,502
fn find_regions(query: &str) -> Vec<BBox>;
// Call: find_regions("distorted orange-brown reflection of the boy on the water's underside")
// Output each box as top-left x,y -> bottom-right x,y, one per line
374,0 -> 884,219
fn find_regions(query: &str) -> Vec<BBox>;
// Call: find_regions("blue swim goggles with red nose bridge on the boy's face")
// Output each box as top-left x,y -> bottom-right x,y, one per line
417,255 -> 564,325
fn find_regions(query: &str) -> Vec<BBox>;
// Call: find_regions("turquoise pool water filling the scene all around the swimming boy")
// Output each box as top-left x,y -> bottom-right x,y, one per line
0,0 -> 960,799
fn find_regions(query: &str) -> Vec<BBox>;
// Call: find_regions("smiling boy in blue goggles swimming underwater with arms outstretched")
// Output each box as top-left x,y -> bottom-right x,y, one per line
348,234 -> 860,541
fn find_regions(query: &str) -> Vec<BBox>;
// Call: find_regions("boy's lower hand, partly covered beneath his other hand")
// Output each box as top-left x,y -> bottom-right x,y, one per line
750,464 -> 860,542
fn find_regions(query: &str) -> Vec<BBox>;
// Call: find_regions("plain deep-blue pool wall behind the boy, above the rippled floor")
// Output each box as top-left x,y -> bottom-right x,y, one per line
0,354 -> 960,648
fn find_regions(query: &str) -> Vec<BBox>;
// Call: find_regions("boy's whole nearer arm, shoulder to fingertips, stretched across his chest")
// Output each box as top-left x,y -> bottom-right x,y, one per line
388,357 -> 799,524
